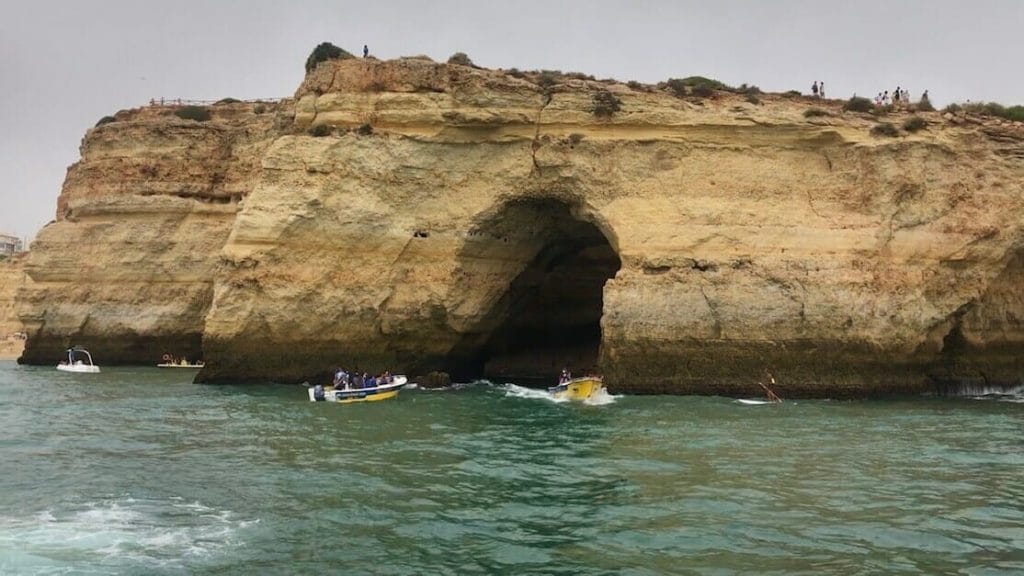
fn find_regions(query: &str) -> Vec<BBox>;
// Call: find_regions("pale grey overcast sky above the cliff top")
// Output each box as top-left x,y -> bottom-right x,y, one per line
0,0 -> 1024,239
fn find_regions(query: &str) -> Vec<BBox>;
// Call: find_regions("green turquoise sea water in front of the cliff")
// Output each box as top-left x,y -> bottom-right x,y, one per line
0,363 -> 1024,575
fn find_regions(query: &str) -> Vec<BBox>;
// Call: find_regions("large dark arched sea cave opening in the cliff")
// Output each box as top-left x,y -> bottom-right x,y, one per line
447,199 -> 622,385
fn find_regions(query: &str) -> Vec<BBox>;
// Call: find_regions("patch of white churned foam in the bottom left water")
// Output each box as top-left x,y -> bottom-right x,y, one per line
0,497 -> 259,573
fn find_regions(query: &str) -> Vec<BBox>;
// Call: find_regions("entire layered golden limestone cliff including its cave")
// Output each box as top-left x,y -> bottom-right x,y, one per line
19,58 -> 1024,396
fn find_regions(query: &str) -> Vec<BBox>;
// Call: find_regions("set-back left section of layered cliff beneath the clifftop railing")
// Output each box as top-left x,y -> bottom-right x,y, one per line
18,104 -> 288,365
